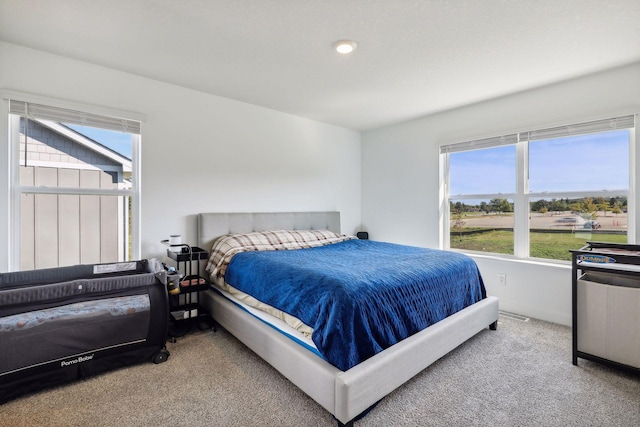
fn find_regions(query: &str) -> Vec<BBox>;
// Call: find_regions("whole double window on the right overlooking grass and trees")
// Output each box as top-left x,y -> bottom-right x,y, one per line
440,116 -> 635,260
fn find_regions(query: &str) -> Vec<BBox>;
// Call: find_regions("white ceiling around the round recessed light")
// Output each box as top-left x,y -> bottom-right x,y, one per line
0,0 -> 640,130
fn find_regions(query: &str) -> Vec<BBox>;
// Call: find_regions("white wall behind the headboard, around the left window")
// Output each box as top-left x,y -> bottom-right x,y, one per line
0,42 -> 361,271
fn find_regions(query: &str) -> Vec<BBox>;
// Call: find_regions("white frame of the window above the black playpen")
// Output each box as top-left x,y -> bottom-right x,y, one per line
0,91 -> 146,271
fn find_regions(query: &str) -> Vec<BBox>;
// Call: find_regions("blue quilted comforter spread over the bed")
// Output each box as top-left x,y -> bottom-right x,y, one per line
225,240 -> 485,371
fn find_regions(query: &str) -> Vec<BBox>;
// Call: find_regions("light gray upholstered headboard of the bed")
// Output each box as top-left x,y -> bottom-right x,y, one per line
198,212 -> 340,251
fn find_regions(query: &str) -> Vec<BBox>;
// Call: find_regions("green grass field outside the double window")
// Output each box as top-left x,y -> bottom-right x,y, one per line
451,230 -> 627,261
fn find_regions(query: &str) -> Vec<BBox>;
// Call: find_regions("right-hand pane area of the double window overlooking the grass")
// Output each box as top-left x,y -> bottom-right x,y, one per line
528,129 -> 631,260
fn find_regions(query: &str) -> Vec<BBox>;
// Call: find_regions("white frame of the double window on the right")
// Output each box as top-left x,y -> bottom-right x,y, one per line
439,113 -> 640,264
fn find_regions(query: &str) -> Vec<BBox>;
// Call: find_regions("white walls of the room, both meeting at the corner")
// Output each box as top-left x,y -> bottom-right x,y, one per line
0,42 -> 640,324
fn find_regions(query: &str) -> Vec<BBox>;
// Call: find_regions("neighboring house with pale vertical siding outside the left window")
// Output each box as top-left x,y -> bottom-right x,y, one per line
20,121 -> 126,270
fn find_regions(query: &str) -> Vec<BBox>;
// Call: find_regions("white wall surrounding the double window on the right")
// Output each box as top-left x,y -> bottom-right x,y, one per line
362,63 -> 640,325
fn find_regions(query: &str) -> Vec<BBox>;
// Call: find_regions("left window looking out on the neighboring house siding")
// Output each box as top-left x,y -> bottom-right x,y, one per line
9,100 -> 140,270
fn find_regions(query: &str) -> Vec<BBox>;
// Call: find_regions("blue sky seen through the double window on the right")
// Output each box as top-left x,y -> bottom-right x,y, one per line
450,130 -> 629,196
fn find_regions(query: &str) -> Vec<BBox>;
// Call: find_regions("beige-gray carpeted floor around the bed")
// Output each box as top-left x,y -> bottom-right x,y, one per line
0,316 -> 640,427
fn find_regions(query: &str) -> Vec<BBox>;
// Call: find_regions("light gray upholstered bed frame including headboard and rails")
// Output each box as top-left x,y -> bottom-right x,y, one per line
198,212 -> 498,426
